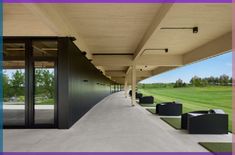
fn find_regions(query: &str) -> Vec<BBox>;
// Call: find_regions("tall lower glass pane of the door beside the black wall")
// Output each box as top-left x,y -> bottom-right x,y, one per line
33,60 -> 57,127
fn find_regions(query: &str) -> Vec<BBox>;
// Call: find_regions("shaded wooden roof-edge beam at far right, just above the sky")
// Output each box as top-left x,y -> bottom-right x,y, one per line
183,32 -> 232,64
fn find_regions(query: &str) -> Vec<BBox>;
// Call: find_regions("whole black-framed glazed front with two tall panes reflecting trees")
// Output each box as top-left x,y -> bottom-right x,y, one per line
2,37 -> 58,128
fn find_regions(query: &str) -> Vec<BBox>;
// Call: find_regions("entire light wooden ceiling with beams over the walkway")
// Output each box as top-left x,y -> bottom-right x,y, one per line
3,3 -> 232,83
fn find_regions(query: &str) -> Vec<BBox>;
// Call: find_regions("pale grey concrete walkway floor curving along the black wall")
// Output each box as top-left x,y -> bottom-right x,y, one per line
4,92 -> 232,152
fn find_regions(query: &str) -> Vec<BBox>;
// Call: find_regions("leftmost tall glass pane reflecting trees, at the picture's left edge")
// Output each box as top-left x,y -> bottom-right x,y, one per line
2,43 -> 25,126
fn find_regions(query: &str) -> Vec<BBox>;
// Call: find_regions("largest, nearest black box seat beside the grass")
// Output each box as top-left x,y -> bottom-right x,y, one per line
181,109 -> 228,134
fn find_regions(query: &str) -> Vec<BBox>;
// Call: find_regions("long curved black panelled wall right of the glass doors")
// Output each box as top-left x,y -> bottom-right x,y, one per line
58,38 -> 113,128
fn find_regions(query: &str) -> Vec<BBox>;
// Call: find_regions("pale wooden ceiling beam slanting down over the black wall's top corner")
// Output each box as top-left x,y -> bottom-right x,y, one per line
24,3 -> 92,59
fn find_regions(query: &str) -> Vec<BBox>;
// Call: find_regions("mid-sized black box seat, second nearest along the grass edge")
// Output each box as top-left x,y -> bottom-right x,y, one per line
156,102 -> 182,116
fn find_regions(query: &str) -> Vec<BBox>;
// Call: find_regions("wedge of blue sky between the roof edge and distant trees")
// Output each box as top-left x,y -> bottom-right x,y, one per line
140,52 -> 232,83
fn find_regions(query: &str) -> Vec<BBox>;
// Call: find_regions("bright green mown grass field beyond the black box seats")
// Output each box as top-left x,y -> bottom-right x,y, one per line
139,86 -> 232,131
